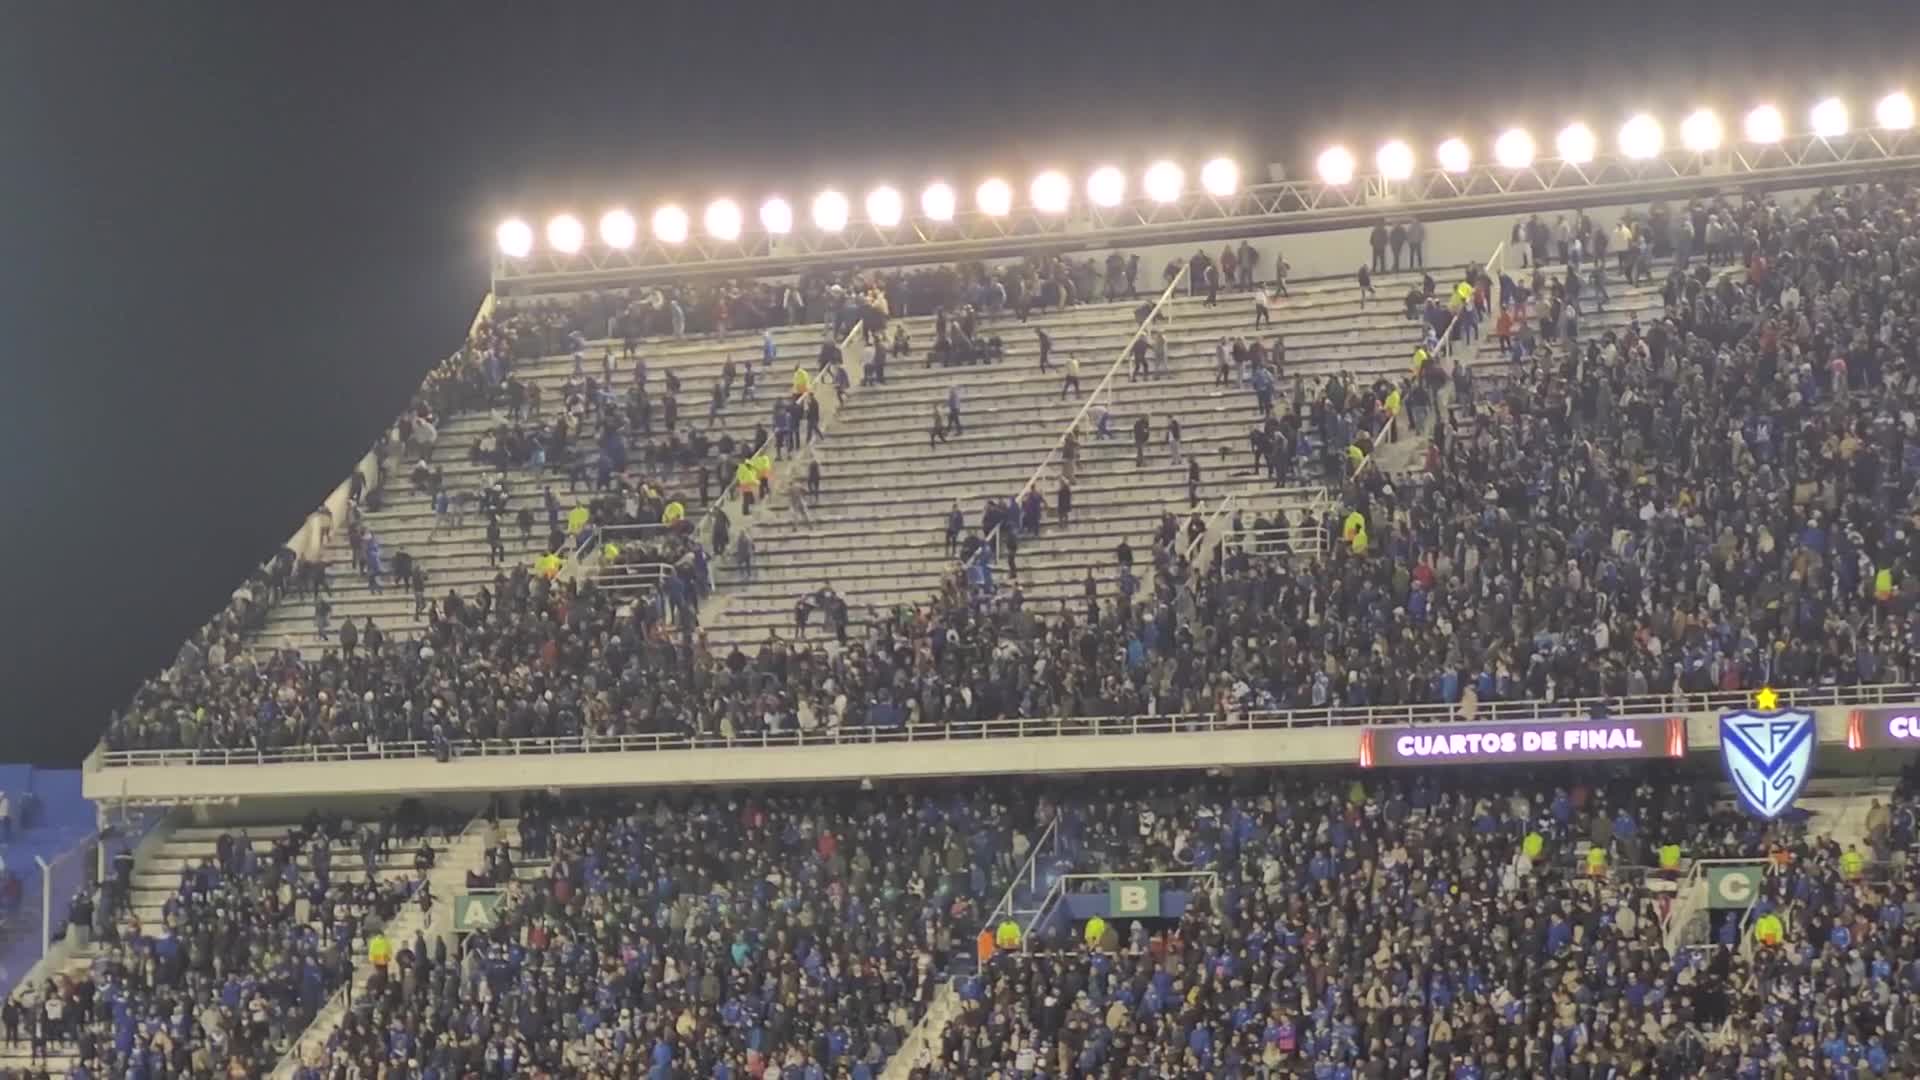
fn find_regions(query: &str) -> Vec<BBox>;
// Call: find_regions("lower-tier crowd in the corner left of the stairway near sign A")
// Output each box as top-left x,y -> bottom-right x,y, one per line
0,807 -> 449,1078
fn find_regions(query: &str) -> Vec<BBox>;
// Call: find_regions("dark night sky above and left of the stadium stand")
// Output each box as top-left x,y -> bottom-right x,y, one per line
0,0 -> 1920,765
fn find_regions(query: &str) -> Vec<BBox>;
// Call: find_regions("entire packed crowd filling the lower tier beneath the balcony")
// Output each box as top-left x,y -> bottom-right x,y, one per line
0,765 -> 1920,1080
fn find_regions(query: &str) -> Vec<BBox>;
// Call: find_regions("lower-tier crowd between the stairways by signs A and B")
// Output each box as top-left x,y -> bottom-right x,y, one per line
295,790 -> 1041,1080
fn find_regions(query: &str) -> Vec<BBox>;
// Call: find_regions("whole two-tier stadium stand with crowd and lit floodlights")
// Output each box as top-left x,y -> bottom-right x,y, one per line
18,82 -> 1920,1080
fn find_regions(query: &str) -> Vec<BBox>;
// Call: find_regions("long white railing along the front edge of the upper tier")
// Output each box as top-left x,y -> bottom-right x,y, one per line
98,682 -> 1920,769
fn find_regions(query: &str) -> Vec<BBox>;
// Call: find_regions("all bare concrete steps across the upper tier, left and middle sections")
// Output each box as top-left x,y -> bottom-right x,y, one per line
255,259 -> 1659,655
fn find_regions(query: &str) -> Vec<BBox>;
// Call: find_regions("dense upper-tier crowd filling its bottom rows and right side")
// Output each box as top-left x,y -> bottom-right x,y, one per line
109,184 -> 1920,748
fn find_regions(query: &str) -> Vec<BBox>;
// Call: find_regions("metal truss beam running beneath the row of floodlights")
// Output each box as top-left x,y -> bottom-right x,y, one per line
493,131 -> 1920,294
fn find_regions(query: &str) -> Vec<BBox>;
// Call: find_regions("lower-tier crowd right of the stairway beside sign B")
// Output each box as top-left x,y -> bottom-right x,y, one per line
916,769 -> 1920,1080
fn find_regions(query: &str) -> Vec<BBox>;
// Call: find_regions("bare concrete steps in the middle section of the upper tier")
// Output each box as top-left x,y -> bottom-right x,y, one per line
707,267 -> 1659,648
